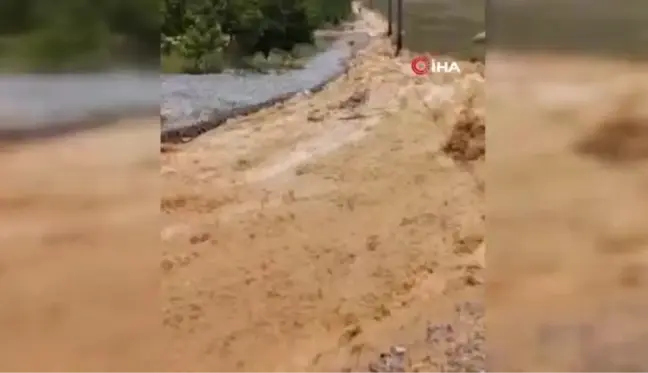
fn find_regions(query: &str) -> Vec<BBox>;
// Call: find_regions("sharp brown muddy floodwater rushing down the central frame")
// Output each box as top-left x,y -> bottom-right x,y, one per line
161,5 -> 485,373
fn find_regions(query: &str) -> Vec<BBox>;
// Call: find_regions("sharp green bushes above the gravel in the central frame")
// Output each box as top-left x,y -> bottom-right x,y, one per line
160,0 -> 351,73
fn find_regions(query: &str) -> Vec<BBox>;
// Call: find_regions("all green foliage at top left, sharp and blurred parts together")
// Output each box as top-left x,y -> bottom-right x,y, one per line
0,0 -> 351,73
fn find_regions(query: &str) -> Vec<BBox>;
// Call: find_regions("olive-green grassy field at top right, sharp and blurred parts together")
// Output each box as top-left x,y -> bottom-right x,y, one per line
365,0 -> 648,60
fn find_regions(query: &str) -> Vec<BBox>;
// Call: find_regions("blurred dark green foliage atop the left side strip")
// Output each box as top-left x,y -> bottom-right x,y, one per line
0,0 -> 161,71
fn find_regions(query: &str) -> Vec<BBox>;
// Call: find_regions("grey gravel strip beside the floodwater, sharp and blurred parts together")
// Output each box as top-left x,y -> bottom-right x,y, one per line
0,32 -> 370,140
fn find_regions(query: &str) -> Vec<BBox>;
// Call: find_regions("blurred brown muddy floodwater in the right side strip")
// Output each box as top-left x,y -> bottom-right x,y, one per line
487,53 -> 648,373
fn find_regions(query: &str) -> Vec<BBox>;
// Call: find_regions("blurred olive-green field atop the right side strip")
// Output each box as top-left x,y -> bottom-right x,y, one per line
488,0 -> 648,60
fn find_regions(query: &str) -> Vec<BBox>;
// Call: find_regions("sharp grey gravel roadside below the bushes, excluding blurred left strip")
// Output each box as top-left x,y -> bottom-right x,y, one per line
161,32 -> 370,142
